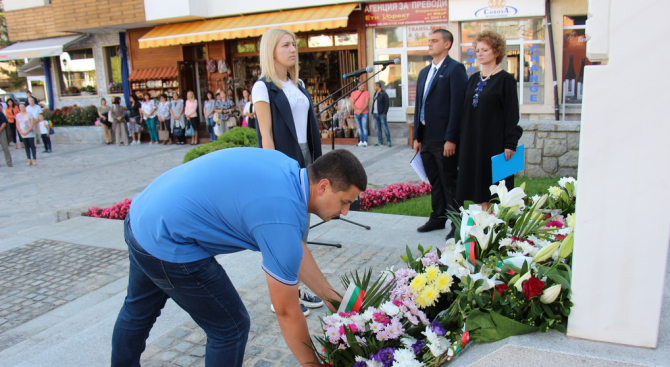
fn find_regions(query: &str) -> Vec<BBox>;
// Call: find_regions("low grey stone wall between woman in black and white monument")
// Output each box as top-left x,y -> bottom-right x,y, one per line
519,121 -> 581,177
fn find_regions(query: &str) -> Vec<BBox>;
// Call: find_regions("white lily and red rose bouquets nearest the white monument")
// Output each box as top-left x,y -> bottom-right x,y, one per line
440,179 -> 576,342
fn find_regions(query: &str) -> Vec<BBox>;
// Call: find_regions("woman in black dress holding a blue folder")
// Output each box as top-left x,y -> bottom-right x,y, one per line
456,30 -> 523,210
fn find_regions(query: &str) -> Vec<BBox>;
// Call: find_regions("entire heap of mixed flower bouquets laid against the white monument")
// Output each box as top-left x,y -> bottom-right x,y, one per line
313,178 -> 577,367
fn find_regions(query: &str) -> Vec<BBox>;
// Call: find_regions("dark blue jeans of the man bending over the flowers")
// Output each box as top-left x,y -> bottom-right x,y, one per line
111,216 -> 250,367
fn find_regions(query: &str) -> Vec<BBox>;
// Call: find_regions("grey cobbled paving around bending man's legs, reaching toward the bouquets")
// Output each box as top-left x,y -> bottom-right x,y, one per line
142,243 -> 404,367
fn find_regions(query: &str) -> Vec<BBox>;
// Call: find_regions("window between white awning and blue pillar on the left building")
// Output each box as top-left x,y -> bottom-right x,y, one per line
55,48 -> 97,95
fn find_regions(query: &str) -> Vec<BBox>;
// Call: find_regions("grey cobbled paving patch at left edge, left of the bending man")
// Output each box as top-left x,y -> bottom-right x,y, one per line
0,240 -> 128,350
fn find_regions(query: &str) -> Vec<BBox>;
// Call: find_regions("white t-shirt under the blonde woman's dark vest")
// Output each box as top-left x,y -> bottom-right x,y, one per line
251,80 -> 309,143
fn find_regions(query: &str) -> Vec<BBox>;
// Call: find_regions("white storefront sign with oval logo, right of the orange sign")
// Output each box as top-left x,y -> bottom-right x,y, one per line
449,0 -> 545,22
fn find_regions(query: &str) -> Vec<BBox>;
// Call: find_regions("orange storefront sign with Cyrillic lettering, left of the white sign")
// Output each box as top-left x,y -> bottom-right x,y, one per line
365,0 -> 449,27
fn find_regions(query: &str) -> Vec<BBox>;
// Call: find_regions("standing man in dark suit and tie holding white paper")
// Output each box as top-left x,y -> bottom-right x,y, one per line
414,29 -> 468,238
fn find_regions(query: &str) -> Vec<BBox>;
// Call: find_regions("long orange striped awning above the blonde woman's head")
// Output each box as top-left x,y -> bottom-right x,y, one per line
139,3 -> 358,48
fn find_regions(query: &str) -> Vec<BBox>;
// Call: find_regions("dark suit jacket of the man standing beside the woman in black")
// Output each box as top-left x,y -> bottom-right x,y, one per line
414,55 -> 468,144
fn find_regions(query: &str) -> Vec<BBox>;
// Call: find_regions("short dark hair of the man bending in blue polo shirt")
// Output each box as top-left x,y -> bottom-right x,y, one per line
307,149 -> 368,192
